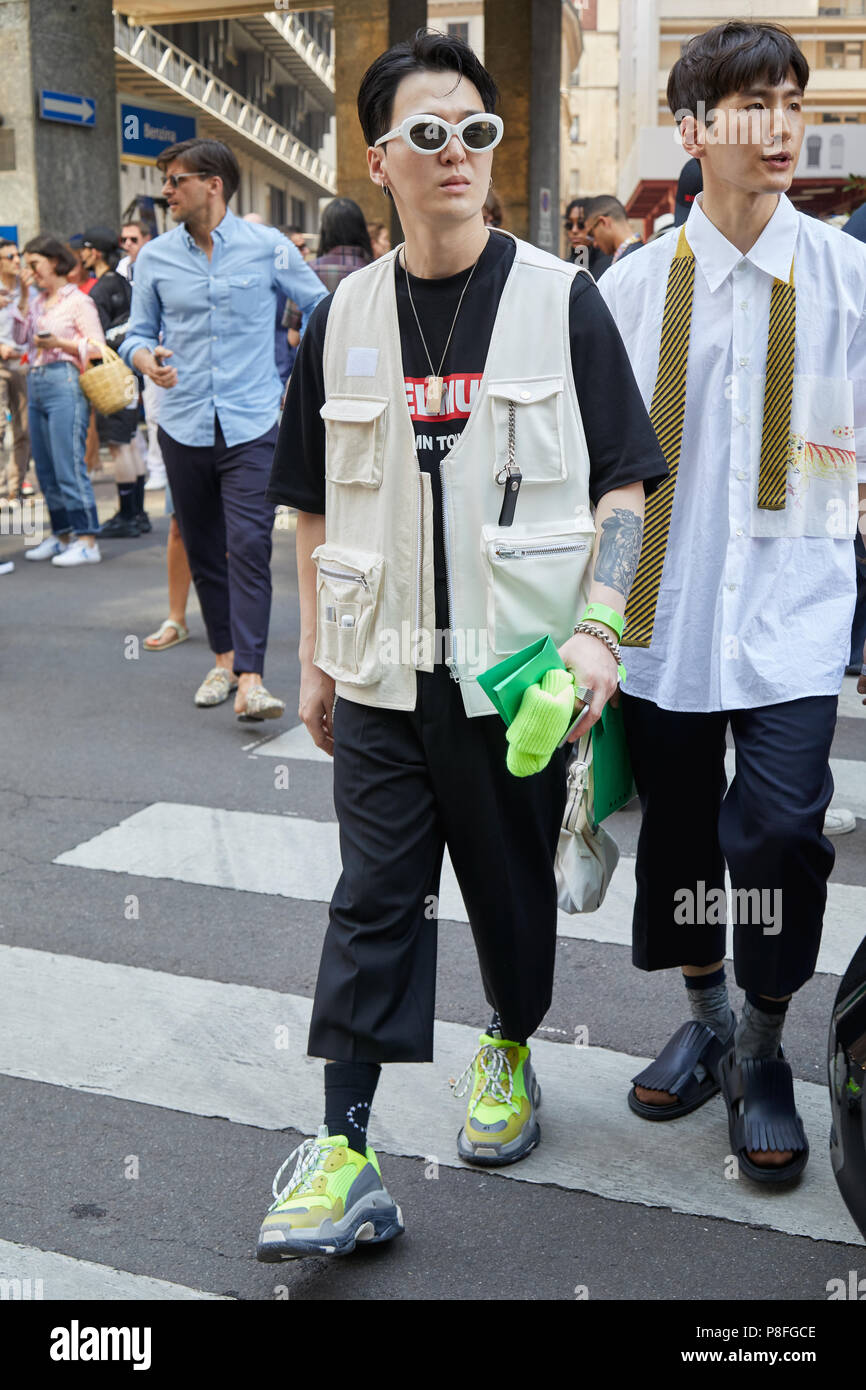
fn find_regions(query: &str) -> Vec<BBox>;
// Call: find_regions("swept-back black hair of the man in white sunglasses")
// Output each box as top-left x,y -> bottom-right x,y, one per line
357,29 -> 499,145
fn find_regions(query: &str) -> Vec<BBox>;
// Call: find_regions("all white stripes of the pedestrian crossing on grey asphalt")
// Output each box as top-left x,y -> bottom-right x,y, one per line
0,711 -> 866,1300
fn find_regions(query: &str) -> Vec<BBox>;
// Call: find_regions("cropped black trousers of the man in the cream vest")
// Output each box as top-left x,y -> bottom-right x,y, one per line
309,666 -> 566,1062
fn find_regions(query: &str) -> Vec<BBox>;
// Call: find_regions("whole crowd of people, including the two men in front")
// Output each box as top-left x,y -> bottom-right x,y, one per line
0,22 -> 866,1261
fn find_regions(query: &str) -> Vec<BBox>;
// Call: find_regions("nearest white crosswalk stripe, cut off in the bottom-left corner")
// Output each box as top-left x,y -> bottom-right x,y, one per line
0,1240 -> 234,1302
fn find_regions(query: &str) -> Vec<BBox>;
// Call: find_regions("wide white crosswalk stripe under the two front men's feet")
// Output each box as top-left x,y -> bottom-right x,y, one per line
0,947 -> 860,1244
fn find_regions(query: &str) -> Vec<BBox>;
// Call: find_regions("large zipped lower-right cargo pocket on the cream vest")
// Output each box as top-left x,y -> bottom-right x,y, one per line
481,513 -> 595,656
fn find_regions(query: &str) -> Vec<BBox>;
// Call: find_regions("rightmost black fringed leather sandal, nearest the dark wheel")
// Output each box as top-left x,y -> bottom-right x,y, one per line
719,1048 -> 809,1183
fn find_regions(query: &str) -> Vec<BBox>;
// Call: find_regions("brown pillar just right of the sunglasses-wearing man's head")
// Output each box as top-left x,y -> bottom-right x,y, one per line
484,0 -> 562,254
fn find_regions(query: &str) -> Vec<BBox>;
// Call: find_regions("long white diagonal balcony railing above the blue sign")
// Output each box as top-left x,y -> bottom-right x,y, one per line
114,14 -> 336,193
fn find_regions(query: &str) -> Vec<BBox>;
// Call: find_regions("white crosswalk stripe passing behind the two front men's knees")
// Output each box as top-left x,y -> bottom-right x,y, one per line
54,802 -> 866,974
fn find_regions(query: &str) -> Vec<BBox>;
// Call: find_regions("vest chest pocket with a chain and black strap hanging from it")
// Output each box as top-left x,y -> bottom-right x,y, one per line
488,377 -> 569,482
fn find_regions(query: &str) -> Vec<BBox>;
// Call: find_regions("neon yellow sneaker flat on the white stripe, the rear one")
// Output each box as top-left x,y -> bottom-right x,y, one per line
453,1033 -> 541,1168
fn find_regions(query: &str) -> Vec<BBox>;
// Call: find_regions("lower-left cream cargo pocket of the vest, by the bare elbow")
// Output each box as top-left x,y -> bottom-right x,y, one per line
313,543 -> 384,685
